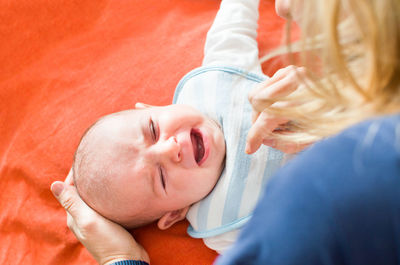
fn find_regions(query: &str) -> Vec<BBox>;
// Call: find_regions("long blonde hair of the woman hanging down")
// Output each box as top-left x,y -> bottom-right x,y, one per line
264,0 -> 400,143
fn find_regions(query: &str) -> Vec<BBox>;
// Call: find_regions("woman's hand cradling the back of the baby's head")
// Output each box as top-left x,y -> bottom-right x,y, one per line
51,178 -> 150,265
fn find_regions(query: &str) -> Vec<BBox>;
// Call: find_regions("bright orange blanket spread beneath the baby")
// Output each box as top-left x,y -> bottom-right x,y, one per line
0,0 -> 283,265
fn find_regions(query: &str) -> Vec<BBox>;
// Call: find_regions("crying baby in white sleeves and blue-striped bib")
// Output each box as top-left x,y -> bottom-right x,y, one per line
73,0 -> 283,252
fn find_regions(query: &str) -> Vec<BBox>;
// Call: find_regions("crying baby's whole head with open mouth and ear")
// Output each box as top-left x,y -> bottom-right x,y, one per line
73,104 -> 225,229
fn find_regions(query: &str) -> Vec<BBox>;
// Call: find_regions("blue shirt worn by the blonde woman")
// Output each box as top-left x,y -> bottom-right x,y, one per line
217,116 -> 400,265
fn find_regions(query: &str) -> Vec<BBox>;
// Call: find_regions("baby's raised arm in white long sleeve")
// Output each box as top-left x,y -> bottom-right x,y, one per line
203,0 -> 261,72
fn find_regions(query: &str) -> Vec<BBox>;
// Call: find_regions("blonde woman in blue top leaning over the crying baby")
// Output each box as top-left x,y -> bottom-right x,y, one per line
52,0 -> 400,264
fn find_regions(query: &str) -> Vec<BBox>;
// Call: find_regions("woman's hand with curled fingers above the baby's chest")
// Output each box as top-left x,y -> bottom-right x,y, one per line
246,65 -> 308,154
